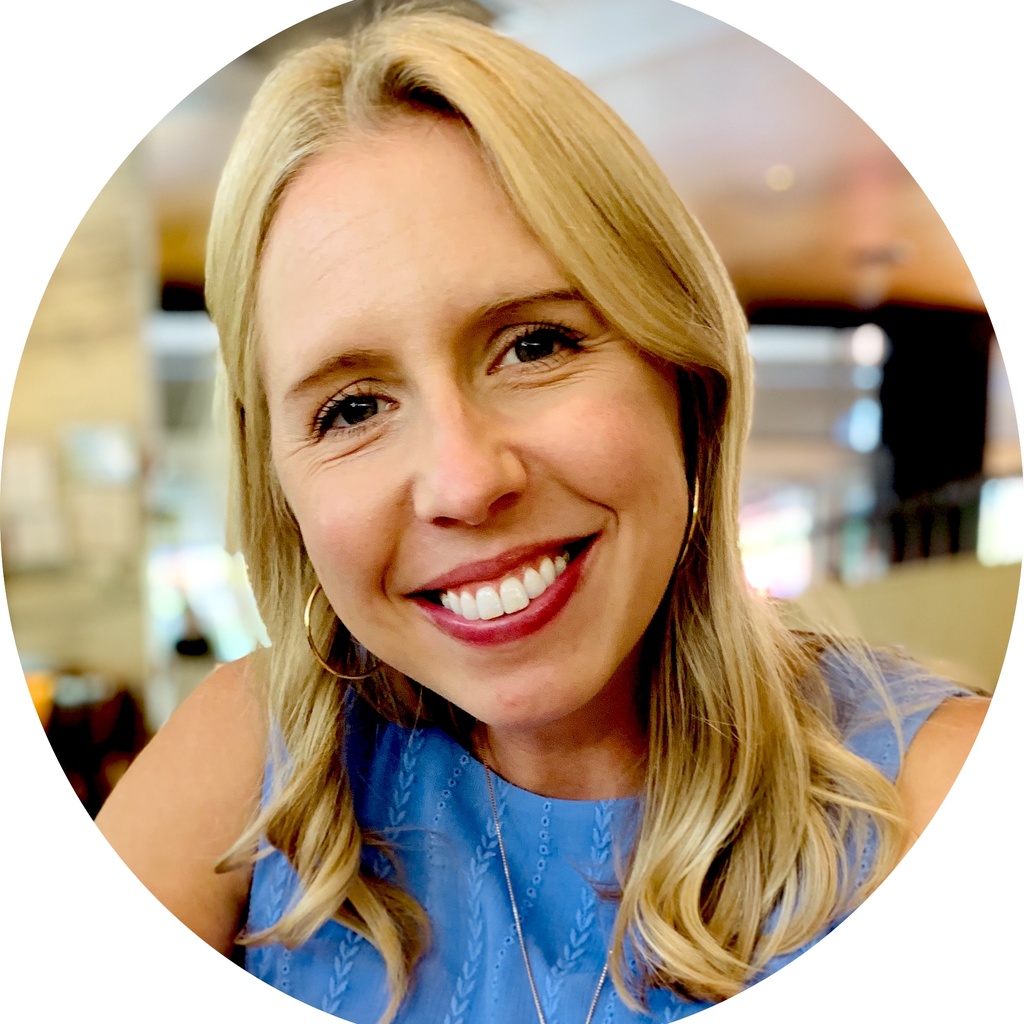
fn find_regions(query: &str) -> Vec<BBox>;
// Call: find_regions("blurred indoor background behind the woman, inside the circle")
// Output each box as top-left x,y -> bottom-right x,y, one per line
0,0 -> 1024,813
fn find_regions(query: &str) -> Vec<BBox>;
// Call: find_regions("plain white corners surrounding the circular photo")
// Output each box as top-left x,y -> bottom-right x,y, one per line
0,0 -> 1024,1024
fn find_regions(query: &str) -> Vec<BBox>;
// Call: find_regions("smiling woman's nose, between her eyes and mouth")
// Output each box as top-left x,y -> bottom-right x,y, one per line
413,389 -> 526,526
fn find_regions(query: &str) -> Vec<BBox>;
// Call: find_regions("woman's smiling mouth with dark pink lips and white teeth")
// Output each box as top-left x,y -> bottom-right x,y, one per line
411,536 -> 596,645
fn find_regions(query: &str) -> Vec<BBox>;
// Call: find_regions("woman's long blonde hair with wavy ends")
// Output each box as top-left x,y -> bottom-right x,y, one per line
207,13 -> 902,1017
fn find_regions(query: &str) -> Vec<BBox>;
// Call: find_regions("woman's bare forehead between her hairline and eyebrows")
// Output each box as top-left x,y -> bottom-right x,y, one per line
259,116 -> 564,372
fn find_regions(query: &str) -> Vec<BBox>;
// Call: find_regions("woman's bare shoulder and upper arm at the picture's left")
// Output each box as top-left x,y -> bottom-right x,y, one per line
96,658 -> 267,953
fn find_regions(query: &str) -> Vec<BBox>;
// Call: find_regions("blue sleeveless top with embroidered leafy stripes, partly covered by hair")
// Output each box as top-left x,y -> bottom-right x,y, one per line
246,655 -> 963,1024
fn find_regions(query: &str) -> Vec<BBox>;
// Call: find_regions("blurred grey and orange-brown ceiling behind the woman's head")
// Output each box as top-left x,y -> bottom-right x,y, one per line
143,0 -> 982,309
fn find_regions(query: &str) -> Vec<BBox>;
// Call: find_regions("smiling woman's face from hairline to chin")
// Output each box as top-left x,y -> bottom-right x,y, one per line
259,117 -> 688,745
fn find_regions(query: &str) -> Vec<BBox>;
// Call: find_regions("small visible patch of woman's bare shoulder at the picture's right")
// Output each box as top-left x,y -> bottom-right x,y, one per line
896,697 -> 989,852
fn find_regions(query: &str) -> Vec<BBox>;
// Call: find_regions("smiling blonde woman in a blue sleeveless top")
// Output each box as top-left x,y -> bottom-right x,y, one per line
99,14 -> 984,1024
